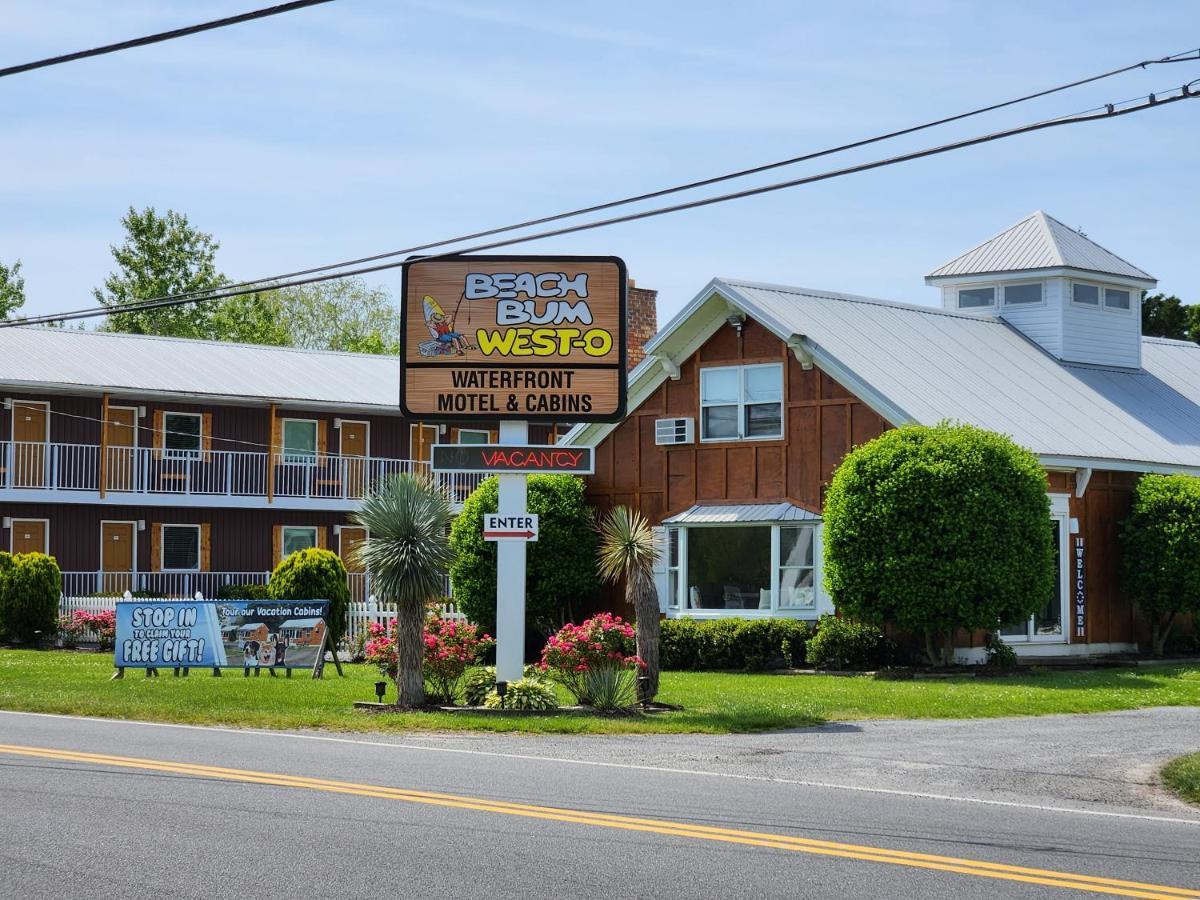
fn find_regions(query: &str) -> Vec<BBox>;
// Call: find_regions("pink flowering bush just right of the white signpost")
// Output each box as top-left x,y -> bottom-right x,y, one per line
539,612 -> 644,709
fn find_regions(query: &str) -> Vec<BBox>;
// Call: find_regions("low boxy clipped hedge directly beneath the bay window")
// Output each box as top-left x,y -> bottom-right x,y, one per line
659,618 -> 811,672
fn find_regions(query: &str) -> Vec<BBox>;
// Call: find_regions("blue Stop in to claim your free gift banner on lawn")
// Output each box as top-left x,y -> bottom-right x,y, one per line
113,600 -> 329,668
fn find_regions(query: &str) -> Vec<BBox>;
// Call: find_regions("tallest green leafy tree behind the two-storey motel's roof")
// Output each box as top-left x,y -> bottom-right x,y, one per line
92,206 -> 228,337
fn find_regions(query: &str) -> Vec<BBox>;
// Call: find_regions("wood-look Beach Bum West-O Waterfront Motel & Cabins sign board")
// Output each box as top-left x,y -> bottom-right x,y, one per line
401,257 -> 625,422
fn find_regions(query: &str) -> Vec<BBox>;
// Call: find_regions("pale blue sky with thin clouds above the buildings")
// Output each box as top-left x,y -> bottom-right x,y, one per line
0,0 -> 1200,322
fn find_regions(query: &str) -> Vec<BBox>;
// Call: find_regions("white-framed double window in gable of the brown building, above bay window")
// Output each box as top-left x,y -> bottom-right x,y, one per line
700,362 -> 784,440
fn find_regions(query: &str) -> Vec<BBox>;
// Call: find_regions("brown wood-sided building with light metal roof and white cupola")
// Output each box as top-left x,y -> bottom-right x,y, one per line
563,212 -> 1200,660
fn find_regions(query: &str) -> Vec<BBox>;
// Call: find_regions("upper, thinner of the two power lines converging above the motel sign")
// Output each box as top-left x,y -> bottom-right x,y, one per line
37,49 -> 1200,321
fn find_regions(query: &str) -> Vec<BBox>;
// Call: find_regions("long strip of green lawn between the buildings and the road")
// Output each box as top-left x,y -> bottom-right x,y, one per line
7,650 -> 1200,733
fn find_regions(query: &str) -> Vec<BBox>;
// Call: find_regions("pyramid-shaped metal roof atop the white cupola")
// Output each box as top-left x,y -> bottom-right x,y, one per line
925,210 -> 1157,283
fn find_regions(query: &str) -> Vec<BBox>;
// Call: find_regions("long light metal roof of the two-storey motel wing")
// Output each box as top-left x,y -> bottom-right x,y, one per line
0,328 -> 400,415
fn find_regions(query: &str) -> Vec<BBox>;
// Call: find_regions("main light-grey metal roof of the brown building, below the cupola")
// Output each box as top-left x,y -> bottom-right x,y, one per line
565,278 -> 1200,472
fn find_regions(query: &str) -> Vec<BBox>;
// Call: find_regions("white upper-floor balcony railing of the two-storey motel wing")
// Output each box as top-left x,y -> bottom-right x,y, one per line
0,440 -> 482,505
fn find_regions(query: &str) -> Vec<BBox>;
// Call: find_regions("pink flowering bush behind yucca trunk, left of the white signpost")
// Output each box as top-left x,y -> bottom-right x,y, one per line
362,614 -> 494,703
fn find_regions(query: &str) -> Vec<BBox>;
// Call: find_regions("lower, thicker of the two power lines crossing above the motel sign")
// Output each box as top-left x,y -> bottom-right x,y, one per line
11,79 -> 1200,328
